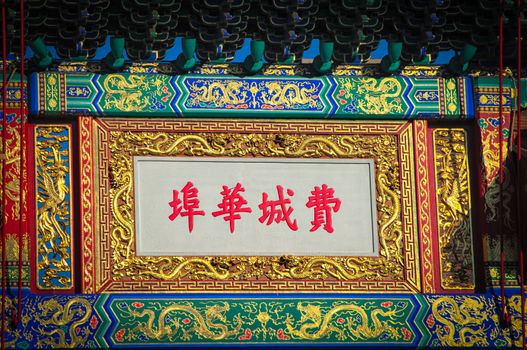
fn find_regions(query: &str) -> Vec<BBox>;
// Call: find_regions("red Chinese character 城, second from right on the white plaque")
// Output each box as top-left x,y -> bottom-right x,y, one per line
258,185 -> 298,231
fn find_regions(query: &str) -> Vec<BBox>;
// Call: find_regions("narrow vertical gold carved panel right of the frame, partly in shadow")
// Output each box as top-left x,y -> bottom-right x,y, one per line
434,129 -> 474,289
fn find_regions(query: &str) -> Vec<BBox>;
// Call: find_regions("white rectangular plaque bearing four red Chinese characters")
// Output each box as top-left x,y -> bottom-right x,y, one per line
134,157 -> 378,256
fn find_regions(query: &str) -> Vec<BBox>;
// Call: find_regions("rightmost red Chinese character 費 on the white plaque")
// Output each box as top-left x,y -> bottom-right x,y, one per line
306,184 -> 340,233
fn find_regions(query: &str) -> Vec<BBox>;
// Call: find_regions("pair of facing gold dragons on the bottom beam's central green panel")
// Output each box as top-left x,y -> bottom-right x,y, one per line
121,301 -> 405,341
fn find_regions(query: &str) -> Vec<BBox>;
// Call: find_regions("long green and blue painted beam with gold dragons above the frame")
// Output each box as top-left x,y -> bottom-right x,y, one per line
30,73 -> 474,119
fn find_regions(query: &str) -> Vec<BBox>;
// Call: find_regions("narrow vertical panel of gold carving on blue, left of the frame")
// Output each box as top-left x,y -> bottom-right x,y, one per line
35,126 -> 72,289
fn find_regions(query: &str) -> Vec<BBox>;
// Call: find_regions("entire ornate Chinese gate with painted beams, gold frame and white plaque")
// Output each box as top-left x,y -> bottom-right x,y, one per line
2,1 -> 527,348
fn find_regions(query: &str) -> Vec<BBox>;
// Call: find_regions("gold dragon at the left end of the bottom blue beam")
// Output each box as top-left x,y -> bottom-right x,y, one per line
34,298 -> 92,349
